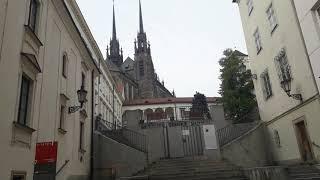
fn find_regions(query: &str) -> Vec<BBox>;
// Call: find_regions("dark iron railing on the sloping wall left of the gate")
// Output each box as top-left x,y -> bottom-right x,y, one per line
96,116 -> 148,153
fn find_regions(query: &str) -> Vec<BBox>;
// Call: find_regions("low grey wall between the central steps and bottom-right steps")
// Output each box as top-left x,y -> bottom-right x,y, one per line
244,166 -> 289,180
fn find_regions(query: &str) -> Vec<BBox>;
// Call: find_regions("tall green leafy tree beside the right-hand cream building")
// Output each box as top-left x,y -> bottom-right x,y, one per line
219,49 -> 257,123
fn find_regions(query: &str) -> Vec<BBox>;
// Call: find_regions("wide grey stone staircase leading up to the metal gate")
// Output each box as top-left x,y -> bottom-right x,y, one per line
120,157 -> 248,180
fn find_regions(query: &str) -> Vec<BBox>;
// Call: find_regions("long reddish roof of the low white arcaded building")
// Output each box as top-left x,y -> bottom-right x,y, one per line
123,97 -> 221,106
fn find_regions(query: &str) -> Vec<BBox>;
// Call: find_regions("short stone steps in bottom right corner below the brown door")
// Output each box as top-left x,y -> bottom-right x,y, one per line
288,164 -> 320,180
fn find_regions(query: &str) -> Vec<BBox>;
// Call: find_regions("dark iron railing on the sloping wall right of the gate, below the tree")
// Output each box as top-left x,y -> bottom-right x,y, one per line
217,122 -> 259,147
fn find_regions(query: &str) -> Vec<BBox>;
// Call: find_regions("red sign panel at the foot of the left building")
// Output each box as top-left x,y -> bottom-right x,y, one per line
35,142 -> 58,164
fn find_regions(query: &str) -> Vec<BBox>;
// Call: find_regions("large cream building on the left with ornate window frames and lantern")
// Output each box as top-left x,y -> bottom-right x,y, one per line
0,0 -> 117,180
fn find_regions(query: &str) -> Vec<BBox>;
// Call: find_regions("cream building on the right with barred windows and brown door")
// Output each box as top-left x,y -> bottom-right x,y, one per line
233,0 -> 320,163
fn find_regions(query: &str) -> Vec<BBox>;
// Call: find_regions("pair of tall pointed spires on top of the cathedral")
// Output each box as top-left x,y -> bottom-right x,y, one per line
107,0 -> 150,66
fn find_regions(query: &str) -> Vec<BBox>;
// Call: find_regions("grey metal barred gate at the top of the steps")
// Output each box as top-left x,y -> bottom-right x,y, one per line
162,123 -> 204,158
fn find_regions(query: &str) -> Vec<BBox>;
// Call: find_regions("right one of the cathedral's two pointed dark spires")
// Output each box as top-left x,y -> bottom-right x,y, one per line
134,0 -> 151,55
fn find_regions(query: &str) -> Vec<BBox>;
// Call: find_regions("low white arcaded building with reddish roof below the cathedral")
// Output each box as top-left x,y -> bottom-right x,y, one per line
123,97 -> 231,129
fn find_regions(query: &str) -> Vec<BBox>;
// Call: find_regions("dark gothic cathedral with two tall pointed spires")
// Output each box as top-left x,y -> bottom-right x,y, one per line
106,2 -> 174,101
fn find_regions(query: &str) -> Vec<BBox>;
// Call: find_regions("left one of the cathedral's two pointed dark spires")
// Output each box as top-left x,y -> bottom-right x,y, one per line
107,2 -> 123,67
